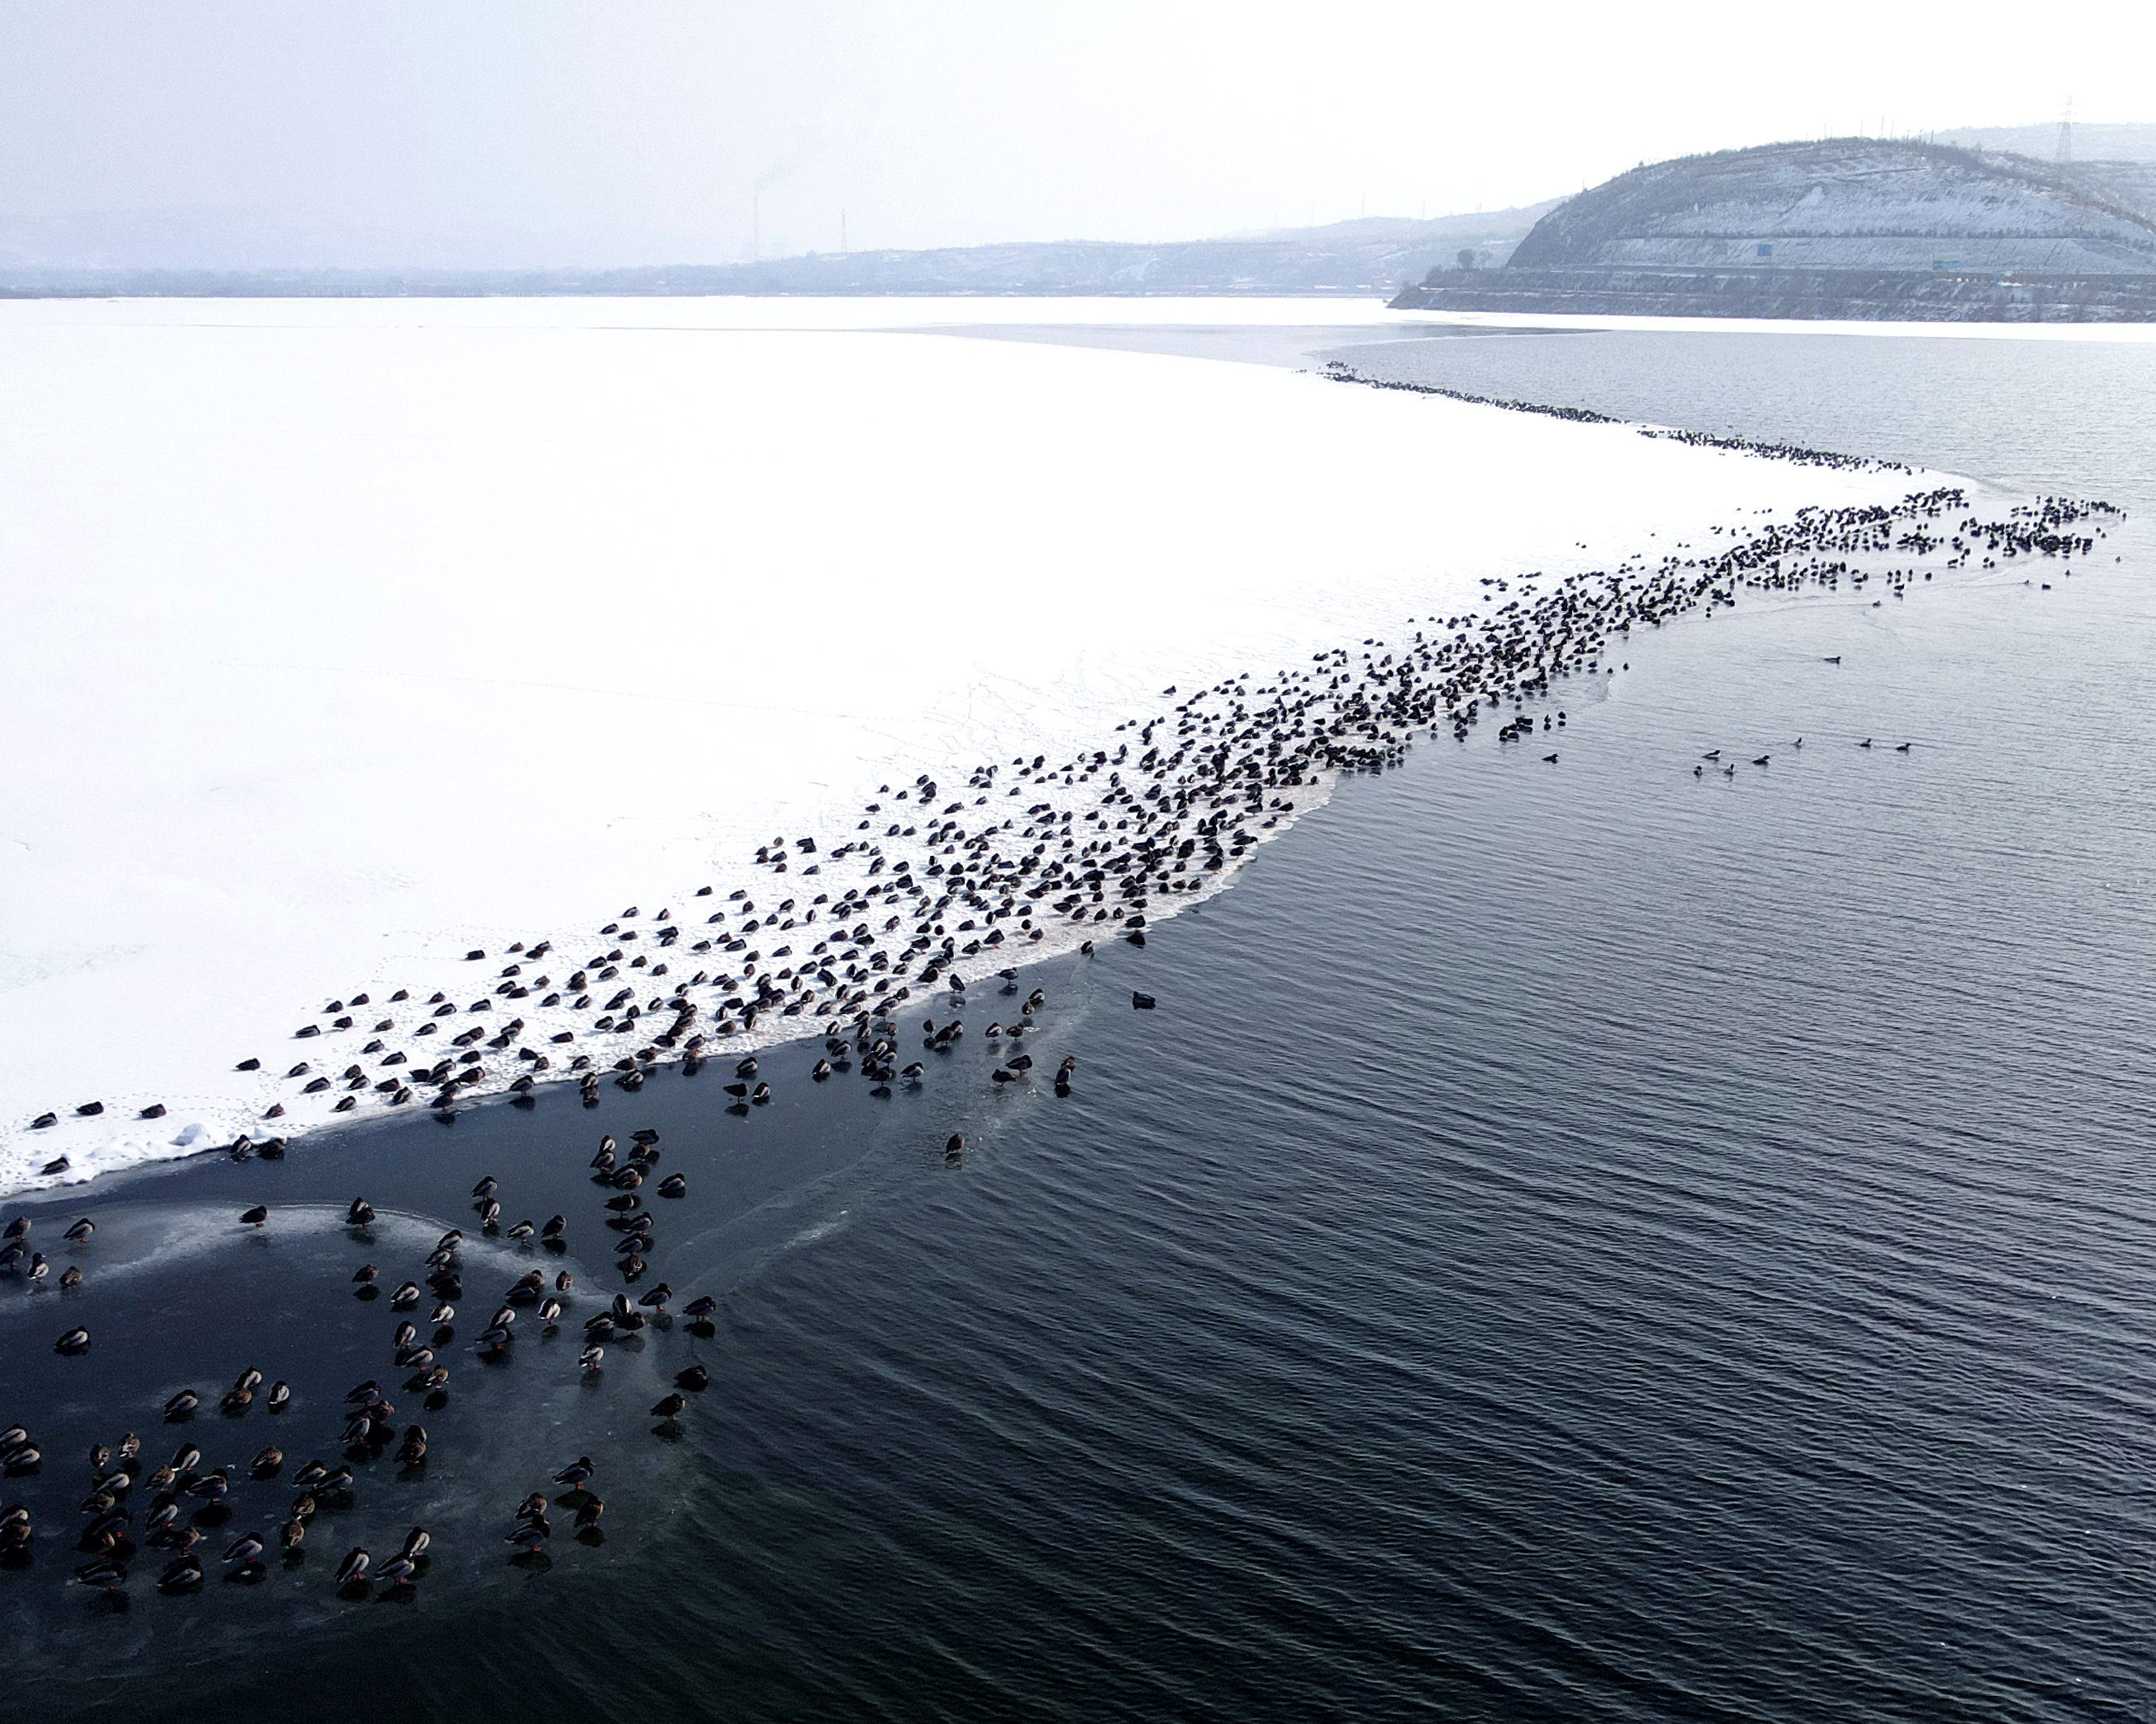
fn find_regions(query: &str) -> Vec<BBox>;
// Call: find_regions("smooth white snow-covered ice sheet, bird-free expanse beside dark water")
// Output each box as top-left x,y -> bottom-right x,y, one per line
0,300 -> 1915,1189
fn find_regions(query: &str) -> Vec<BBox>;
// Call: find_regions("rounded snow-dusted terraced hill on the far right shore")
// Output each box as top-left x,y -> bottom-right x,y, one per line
1507,138 -> 2156,276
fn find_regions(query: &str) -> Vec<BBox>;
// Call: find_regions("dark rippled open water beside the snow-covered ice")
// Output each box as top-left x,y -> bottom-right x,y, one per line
0,336 -> 2156,1720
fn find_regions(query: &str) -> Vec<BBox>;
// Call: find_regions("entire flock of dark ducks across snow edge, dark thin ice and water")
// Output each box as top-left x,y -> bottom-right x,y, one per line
0,457 -> 2115,1620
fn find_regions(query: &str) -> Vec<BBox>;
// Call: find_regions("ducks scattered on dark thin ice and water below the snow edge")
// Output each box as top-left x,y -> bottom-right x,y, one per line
0,969 -> 1095,1603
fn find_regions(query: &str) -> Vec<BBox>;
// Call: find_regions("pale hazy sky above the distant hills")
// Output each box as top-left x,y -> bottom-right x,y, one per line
0,0 -> 2156,263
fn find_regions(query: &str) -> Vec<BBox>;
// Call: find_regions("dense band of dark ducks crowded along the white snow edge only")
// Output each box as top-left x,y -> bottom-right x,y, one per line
8,478 -> 2117,1179
